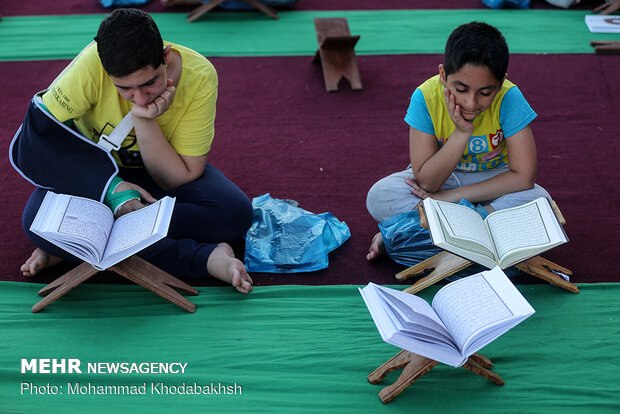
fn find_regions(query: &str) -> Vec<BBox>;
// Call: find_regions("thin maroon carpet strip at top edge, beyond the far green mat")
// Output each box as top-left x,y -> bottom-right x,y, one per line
0,0 -> 603,16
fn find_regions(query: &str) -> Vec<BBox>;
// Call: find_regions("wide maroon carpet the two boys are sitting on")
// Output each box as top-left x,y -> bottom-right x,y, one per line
0,55 -> 620,285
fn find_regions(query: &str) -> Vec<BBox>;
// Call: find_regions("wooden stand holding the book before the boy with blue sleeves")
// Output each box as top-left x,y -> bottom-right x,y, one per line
396,201 -> 579,293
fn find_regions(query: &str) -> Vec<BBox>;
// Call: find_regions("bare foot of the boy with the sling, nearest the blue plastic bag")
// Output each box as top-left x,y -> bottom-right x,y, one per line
207,243 -> 252,293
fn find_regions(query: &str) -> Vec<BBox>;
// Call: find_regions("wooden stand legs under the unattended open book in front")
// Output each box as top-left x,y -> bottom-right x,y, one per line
368,350 -> 504,404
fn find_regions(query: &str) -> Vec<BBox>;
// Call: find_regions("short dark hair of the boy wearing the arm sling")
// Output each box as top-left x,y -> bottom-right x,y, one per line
95,8 -> 164,78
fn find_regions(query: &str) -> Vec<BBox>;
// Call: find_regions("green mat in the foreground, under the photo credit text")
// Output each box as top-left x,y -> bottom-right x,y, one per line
0,282 -> 620,414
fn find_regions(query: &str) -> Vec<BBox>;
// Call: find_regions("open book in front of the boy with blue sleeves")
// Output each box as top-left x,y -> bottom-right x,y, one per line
424,198 -> 568,269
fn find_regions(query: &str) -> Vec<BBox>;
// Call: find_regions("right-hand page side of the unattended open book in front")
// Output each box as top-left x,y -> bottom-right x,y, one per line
433,267 -> 534,356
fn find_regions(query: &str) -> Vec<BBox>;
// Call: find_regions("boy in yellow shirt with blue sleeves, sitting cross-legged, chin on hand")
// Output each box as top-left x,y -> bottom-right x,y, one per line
366,22 -> 550,260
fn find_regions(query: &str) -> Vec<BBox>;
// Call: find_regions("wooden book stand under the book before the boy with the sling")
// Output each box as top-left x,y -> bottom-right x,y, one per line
32,256 -> 198,313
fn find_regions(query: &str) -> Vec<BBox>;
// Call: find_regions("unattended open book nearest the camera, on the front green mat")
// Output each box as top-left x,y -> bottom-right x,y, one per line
360,267 -> 534,367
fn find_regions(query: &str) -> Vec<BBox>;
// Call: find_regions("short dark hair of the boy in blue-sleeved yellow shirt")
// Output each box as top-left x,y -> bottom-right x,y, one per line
444,22 -> 509,82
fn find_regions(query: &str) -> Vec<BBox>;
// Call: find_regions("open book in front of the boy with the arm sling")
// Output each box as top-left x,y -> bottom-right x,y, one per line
30,191 -> 175,270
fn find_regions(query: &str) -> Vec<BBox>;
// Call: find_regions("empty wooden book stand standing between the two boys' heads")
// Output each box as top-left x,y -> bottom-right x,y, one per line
312,17 -> 362,92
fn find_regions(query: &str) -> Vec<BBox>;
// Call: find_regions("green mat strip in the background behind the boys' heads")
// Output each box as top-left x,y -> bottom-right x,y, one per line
0,9 -> 620,61
